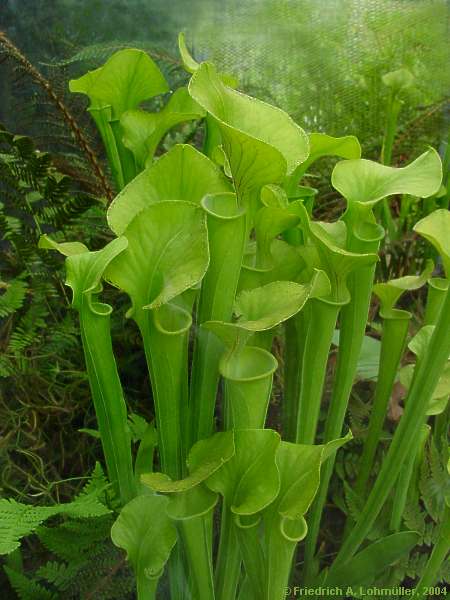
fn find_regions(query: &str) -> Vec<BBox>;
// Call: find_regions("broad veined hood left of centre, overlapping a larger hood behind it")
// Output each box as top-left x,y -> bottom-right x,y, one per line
105,201 -> 209,321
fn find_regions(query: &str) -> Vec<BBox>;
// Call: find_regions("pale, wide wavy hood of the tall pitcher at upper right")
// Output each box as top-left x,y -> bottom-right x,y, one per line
331,148 -> 442,206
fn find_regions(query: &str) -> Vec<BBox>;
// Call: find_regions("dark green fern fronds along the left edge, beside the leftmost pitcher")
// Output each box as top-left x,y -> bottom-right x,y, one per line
0,123 -> 93,377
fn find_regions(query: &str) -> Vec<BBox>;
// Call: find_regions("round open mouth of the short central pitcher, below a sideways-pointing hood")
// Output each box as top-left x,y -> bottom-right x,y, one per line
220,346 -> 278,382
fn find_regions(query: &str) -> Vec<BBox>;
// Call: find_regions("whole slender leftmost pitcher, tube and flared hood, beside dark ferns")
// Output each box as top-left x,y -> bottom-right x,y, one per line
40,237 -> 136,505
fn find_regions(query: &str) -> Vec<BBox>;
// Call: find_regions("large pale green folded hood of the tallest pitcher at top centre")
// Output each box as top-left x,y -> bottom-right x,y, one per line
189,63 -> 309,214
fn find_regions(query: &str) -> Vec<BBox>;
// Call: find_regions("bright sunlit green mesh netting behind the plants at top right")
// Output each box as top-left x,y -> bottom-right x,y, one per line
185,0 -> 450,141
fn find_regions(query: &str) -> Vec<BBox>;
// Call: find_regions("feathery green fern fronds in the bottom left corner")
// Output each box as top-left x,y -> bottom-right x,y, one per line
0,465 -> 133,600
